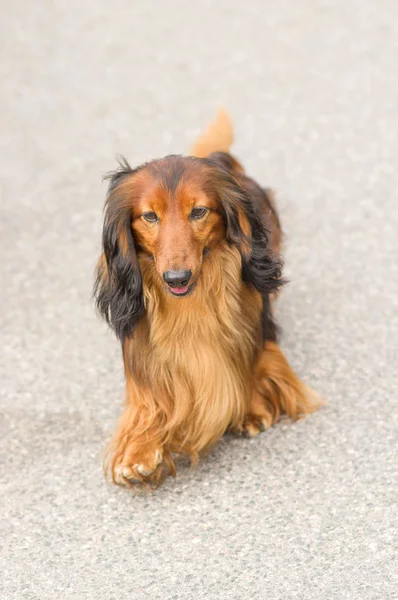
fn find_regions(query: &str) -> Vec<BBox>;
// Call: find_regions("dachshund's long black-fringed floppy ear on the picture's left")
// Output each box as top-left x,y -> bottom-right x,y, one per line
94,162 -> 144,341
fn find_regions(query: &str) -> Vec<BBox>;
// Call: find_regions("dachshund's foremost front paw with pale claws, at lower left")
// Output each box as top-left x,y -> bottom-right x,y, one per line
114,448 -> 163,485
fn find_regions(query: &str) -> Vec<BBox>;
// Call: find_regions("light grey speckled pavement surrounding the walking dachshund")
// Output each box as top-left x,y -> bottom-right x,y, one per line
0,0 -> 398,600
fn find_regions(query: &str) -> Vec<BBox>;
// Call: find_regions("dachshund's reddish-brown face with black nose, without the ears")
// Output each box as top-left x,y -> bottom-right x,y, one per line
132,163 -> 225,298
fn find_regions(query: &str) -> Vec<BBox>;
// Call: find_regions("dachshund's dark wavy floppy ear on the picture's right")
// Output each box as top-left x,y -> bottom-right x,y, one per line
211,169 -> 283,294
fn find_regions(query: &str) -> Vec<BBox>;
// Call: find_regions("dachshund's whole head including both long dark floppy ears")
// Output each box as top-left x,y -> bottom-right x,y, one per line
95,156 -> 280,340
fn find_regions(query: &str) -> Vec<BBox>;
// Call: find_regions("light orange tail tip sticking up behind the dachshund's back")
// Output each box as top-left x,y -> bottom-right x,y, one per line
191,108 -> 234,158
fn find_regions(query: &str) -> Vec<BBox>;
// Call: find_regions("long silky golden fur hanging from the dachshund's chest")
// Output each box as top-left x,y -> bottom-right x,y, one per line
132,249 -> 261,451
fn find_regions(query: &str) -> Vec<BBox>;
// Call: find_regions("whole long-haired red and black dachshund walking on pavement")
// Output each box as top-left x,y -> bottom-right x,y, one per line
95,111 -> 317,483
